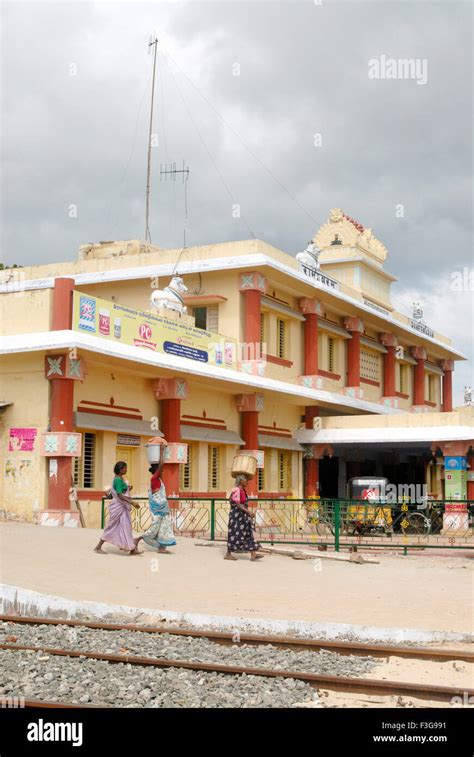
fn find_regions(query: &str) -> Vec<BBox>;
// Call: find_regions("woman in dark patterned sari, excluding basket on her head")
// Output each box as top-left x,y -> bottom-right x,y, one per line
224,474 -> 263,560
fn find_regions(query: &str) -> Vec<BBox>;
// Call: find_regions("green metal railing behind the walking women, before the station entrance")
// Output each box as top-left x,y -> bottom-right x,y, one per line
101,497 -> 474,554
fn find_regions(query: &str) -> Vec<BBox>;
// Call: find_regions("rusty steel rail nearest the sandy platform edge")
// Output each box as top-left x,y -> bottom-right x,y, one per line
0,615 -> 474,662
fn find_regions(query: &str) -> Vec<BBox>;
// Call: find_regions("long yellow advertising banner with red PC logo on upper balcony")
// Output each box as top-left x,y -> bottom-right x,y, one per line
72,292 -> 237,369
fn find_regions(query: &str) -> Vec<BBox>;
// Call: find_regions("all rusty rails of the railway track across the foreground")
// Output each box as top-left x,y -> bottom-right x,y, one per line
0,615 -> 474,707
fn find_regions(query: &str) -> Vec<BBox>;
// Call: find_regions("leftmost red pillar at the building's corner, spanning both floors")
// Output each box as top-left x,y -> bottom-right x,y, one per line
48,278 -> 74,510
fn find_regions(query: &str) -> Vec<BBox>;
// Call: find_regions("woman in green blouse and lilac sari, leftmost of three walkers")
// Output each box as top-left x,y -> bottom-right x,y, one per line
94,460 -> 141,555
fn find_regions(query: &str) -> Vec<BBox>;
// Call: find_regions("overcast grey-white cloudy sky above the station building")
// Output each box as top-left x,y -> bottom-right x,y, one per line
1,0 -> 473,402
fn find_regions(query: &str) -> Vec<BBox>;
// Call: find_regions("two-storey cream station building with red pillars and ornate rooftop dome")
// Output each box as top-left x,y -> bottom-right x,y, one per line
0,209 -> 474,527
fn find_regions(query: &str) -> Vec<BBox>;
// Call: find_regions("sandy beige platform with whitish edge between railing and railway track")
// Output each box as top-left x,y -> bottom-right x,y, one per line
0,522 -> 474,642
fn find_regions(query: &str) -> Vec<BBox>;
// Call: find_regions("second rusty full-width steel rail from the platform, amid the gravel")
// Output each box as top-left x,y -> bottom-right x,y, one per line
0,644 -> 474,702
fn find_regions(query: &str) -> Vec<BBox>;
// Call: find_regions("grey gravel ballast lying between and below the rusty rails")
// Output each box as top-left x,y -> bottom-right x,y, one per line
0,622 -> 378,708
